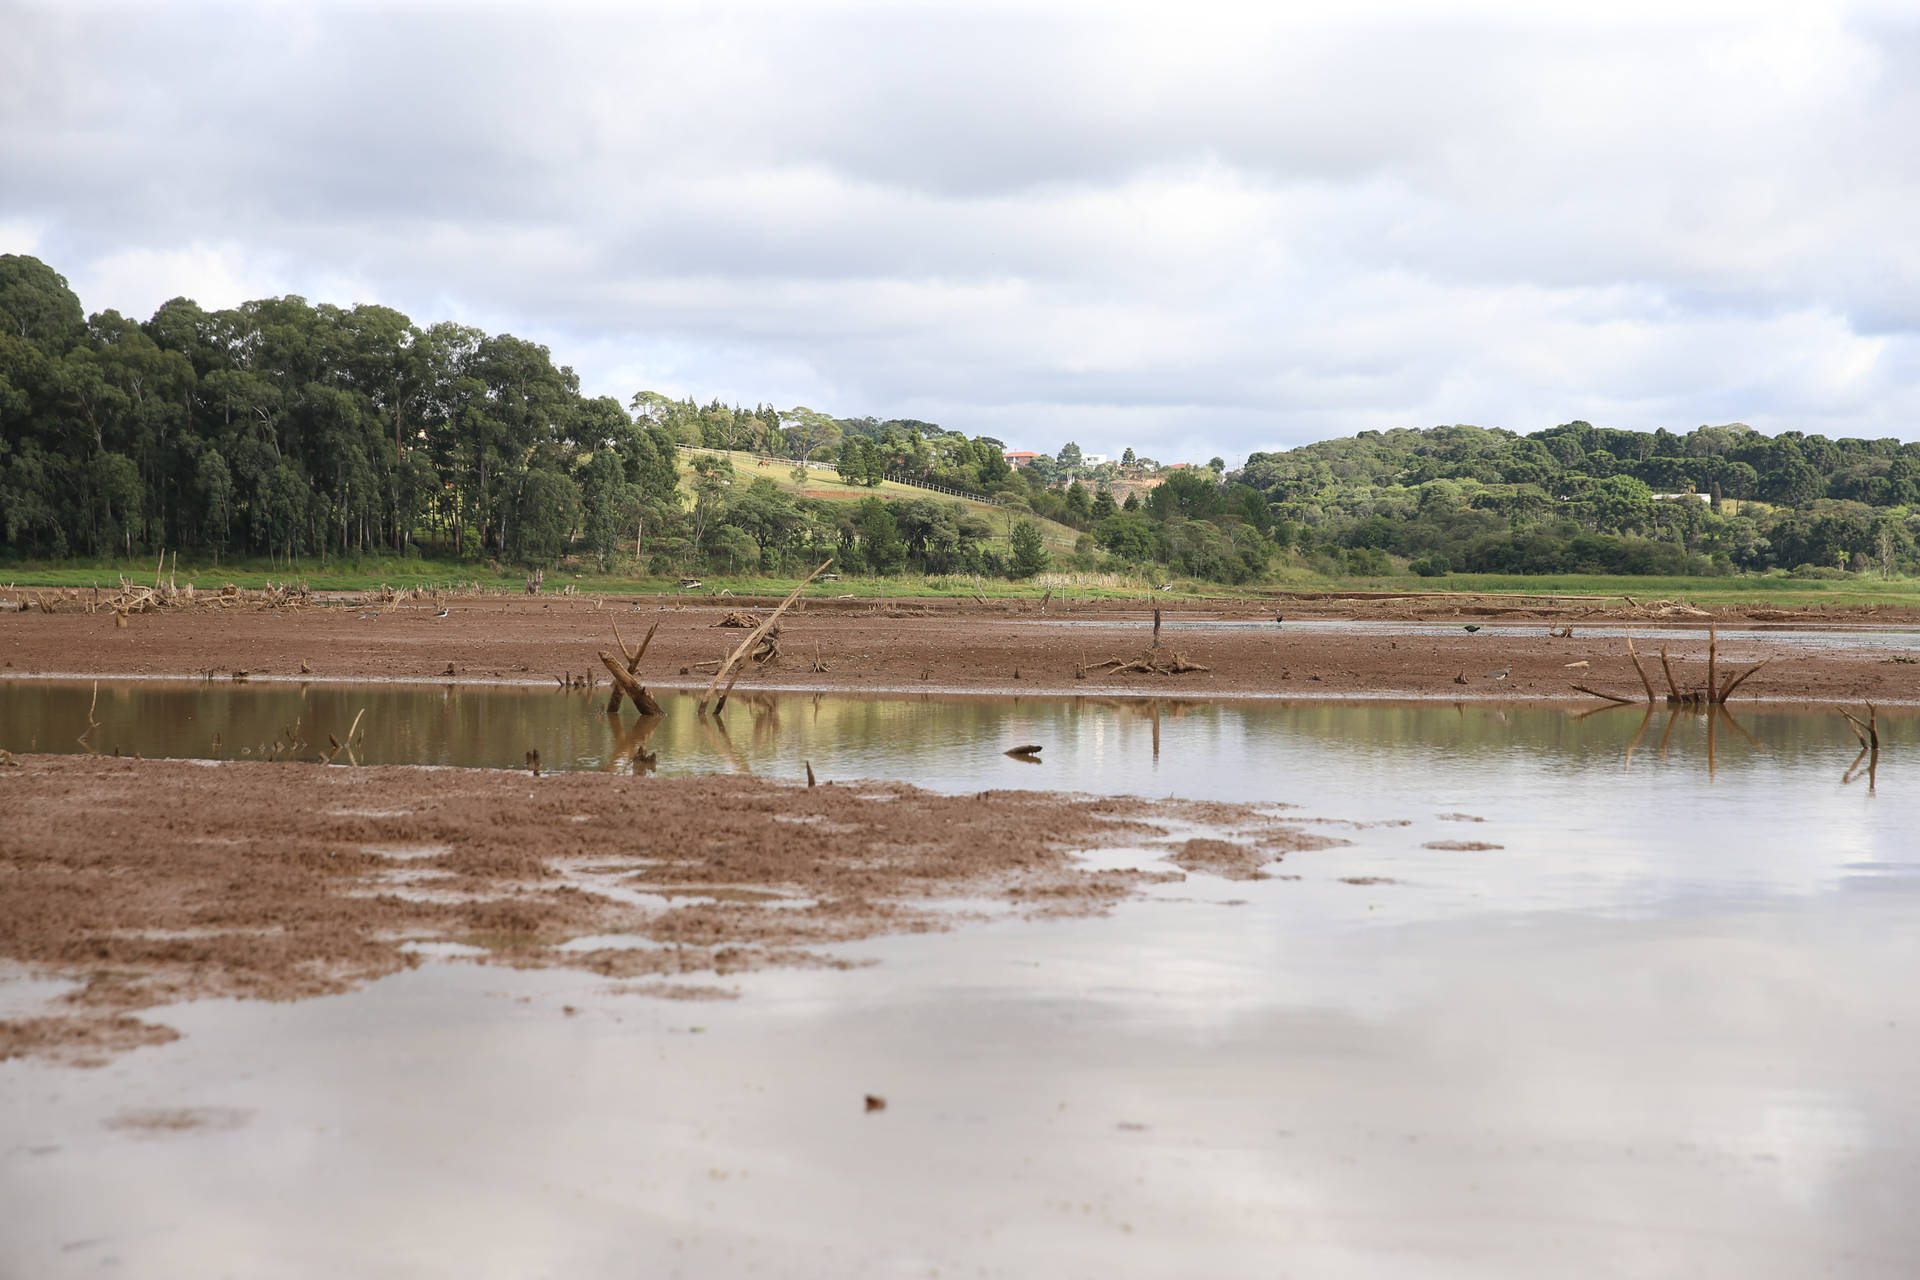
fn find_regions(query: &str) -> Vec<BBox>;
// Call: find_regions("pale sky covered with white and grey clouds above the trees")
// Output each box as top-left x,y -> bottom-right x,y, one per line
0,0 -> 1920,464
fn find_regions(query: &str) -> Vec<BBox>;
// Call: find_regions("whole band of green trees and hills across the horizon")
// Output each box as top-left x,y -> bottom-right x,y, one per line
0,255 -> 1920,581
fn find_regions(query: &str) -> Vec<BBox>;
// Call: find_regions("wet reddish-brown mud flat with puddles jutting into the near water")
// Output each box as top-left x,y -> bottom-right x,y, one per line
0,756 -> 1323,1065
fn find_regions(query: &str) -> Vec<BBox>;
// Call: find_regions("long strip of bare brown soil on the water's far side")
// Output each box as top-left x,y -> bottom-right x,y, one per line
0,597 -> 1920,702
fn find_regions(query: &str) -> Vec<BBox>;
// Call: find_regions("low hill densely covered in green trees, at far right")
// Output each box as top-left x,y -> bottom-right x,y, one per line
1236,422 -> 1920,578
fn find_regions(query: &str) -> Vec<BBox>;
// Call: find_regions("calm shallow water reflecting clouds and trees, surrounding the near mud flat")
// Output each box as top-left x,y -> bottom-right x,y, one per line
0,681 -> 1920,1276
